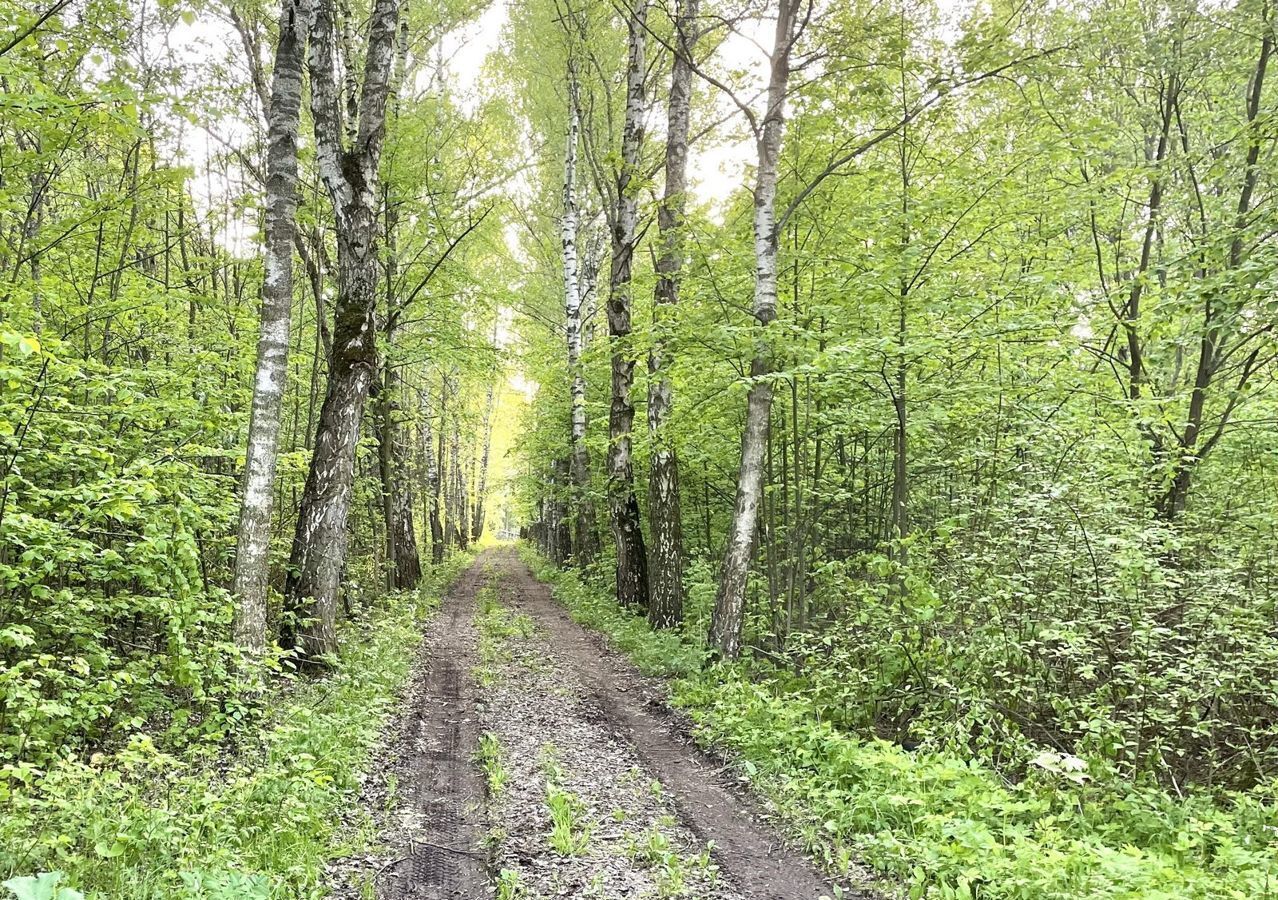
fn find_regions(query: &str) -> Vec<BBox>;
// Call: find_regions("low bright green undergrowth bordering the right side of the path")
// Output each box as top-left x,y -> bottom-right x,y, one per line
527,554 -> 1278,900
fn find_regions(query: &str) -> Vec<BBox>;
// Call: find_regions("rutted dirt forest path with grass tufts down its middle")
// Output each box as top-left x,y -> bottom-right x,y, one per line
347,548 -> 865,900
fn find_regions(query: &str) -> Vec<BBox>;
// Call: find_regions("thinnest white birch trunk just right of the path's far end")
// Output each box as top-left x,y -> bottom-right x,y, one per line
560,80 -> 599,566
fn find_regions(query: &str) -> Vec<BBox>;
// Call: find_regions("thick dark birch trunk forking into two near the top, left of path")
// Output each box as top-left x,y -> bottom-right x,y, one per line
285,0 -> 399,661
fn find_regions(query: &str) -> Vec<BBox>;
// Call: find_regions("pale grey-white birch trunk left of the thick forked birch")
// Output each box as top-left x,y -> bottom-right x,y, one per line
233,0 -> 311,656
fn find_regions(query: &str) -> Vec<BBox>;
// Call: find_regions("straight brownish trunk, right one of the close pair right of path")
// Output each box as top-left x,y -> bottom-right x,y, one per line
648,0 -> 700,628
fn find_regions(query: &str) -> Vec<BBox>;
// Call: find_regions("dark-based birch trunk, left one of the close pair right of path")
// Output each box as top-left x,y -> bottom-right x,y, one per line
607,0 -> 648,610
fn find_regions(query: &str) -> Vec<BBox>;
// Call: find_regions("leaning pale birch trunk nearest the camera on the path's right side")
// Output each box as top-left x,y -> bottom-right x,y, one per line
709,0 -> 799,660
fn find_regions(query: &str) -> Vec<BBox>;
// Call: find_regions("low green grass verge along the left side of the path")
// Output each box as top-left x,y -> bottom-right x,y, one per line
0,556 -> 470,900
